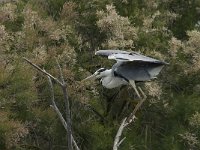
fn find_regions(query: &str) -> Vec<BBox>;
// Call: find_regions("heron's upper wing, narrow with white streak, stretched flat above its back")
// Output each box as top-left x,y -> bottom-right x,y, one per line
95,50 -> 167,64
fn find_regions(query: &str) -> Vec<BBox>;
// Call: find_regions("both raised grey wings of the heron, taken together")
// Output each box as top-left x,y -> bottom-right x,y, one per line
95,50 -> 167,81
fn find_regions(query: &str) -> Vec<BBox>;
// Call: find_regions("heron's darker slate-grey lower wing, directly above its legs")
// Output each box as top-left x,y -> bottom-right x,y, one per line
113,61 -> 164,81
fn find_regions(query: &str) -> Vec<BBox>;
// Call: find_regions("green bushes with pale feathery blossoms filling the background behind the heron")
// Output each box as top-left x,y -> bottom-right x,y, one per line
0,0 -> 200,150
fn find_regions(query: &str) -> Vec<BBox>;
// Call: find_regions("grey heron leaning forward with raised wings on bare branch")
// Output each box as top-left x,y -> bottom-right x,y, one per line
83,50 -> 168,98
